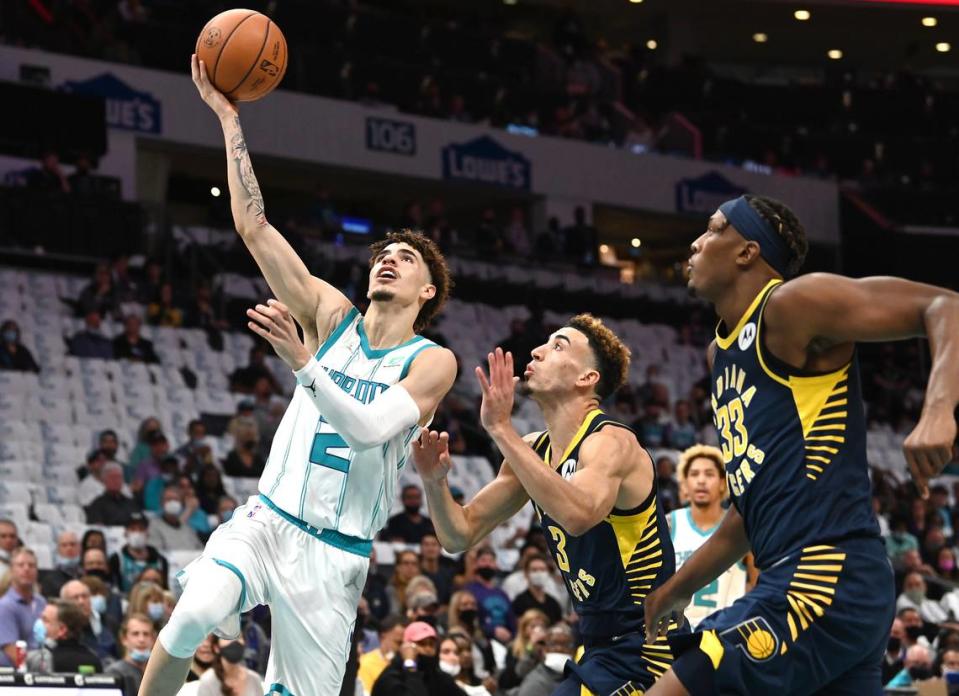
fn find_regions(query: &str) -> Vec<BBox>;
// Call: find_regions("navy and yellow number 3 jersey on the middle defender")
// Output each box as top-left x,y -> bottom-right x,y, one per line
533,409 -> 674,641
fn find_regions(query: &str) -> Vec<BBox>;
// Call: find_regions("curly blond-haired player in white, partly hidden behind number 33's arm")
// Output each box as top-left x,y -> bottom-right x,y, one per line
666,445 -> 758,628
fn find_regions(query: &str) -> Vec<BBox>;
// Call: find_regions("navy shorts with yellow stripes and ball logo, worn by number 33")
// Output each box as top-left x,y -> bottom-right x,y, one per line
669,538 -> 896,696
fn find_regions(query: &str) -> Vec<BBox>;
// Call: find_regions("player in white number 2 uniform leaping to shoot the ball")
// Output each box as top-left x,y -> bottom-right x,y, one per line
140,56 -> 456,696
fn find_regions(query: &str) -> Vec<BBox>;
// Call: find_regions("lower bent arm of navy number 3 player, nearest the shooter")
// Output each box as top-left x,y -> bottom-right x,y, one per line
413,428 -> 532,553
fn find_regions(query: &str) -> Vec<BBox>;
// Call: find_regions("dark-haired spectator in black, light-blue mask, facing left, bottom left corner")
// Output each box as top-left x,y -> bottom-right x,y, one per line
27,599 -> 103,674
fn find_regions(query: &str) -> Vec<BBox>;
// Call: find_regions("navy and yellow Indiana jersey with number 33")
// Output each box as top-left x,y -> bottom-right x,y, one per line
712,279 -> 879,569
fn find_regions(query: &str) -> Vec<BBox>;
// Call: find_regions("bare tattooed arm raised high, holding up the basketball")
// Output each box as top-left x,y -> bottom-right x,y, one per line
191,55 -> 350,350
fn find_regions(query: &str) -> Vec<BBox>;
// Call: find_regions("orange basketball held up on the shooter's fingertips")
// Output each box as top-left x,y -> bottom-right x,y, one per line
196,10 -> 286,101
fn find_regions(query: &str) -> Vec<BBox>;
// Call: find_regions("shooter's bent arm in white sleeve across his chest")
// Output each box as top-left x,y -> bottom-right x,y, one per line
247,300 -> 456,451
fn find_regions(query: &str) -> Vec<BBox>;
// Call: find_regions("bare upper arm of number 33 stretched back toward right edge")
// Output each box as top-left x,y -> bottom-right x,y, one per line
764,273 -> 959,347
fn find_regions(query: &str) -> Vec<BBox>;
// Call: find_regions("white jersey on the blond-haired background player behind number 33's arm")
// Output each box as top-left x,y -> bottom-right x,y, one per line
669,507 -> 746,628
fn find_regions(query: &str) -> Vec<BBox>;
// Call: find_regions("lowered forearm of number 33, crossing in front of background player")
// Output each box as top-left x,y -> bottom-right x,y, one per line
643,507 -> 749,643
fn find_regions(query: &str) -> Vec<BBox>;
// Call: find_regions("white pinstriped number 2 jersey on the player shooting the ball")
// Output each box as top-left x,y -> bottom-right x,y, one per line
259,308 -> 436,539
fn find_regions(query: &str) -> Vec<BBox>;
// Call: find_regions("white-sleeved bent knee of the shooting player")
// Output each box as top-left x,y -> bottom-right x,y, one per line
158,559 -> 243,658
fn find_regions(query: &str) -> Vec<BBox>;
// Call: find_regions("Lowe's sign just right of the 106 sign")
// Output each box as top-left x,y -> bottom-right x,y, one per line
443,135 -> 531,191
